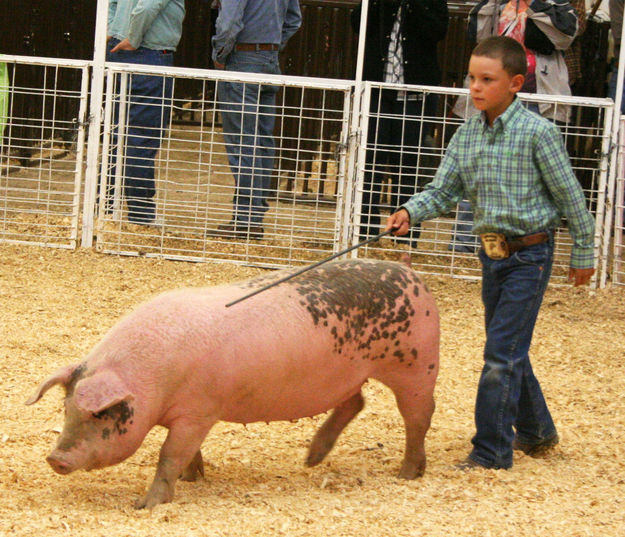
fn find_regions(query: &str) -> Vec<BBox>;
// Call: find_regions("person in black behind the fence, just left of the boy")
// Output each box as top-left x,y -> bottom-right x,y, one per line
352,0 -> 449,247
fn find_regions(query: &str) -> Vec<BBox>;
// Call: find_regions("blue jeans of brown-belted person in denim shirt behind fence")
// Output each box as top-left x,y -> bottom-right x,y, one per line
217,50 -> 280,225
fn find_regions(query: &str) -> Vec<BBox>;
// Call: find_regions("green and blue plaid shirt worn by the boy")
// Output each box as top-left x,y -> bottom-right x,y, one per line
404,98 -> 595,268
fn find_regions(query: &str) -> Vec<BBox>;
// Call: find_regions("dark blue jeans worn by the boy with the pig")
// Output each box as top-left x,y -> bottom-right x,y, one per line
469,236 -> 556,468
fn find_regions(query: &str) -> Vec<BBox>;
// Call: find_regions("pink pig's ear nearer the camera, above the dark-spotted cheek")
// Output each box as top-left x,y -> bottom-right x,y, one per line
74,371 -> 134,414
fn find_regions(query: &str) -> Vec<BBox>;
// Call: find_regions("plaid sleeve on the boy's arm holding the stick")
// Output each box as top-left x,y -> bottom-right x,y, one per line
403,132 -> 464,225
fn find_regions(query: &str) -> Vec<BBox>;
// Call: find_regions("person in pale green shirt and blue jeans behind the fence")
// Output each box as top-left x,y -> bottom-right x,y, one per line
106,0 -> 185,225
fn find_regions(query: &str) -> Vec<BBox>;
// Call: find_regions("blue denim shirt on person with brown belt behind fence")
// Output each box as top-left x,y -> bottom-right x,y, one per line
213,0 -> 302,63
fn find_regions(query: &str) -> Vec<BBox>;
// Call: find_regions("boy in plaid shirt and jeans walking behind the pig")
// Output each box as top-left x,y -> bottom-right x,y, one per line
386,36 -> 594,469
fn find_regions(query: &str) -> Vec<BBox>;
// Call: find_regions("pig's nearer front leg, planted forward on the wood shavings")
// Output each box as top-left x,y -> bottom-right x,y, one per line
135,420 -> 215,509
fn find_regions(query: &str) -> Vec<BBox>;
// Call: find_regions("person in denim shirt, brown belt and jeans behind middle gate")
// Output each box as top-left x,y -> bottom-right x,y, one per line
207,0 -> 302,239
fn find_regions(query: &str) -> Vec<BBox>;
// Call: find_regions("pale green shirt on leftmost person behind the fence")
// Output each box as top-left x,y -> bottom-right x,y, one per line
107,0 -> 184,50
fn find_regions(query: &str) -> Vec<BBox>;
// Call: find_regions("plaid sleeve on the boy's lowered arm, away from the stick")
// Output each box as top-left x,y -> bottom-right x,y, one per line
536,124 -> 595,268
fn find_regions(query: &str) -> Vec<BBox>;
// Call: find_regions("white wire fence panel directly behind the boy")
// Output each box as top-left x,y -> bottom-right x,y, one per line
351,83 -> 612,282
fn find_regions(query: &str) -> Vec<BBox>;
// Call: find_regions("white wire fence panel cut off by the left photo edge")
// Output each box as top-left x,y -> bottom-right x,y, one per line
0,56 -> 89,248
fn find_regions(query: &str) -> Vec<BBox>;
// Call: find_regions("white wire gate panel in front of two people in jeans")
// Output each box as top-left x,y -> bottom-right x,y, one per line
90,64 -> 352,267
